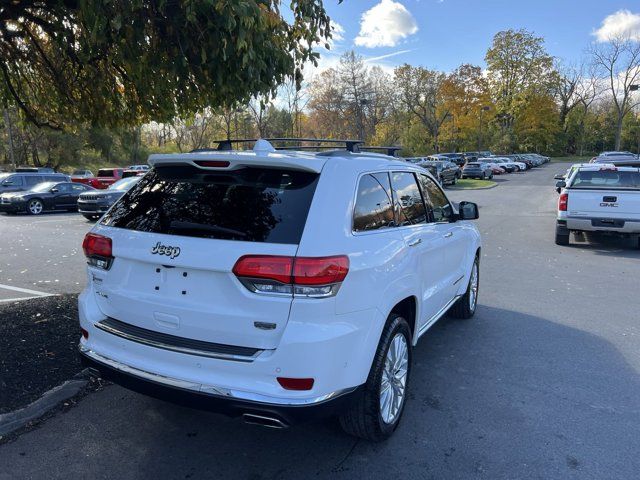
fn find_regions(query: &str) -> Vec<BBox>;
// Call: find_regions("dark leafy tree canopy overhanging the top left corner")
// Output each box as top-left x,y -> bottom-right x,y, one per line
0,0 -> 331,129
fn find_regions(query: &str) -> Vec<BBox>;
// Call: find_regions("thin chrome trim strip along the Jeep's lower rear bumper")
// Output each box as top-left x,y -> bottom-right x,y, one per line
78,344 -> 357,407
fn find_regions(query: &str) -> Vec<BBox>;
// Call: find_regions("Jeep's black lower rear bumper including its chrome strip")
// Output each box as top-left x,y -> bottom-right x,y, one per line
79,345 -> 362,426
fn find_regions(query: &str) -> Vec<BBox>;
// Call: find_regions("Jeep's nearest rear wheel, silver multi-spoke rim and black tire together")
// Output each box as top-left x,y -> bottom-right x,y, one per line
340,313 -> 411,442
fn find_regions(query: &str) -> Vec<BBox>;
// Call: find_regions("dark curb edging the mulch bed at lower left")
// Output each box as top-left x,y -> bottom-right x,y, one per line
0,369 -> 89,436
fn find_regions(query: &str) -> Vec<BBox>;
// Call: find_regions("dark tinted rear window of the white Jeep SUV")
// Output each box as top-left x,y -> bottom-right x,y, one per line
102,166 -> 318,244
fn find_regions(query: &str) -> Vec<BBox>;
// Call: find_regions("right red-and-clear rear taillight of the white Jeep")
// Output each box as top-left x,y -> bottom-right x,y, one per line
233,255 -> 349,297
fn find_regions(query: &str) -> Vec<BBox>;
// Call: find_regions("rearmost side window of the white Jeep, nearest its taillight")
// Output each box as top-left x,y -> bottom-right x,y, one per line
353,173 -> 395,232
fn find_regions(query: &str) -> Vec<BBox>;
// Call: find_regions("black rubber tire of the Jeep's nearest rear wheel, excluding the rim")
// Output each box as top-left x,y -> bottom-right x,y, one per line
339,313 -> 412,442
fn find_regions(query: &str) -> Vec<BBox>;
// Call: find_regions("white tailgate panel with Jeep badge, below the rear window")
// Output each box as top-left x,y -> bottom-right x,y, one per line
91,227 -> 297,349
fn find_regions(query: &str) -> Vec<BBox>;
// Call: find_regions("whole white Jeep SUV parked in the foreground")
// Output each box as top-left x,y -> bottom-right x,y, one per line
79,140 -> 481,440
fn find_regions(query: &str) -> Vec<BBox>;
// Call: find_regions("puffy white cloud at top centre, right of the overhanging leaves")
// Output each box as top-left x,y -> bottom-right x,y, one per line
355,0 -> 418,48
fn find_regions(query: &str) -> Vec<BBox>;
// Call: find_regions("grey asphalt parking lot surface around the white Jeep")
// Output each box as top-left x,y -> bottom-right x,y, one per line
0,164 -> 640,480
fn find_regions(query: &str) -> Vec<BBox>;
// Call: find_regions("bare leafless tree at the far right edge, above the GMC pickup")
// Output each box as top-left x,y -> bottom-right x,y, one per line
590,37 -> 640,150
